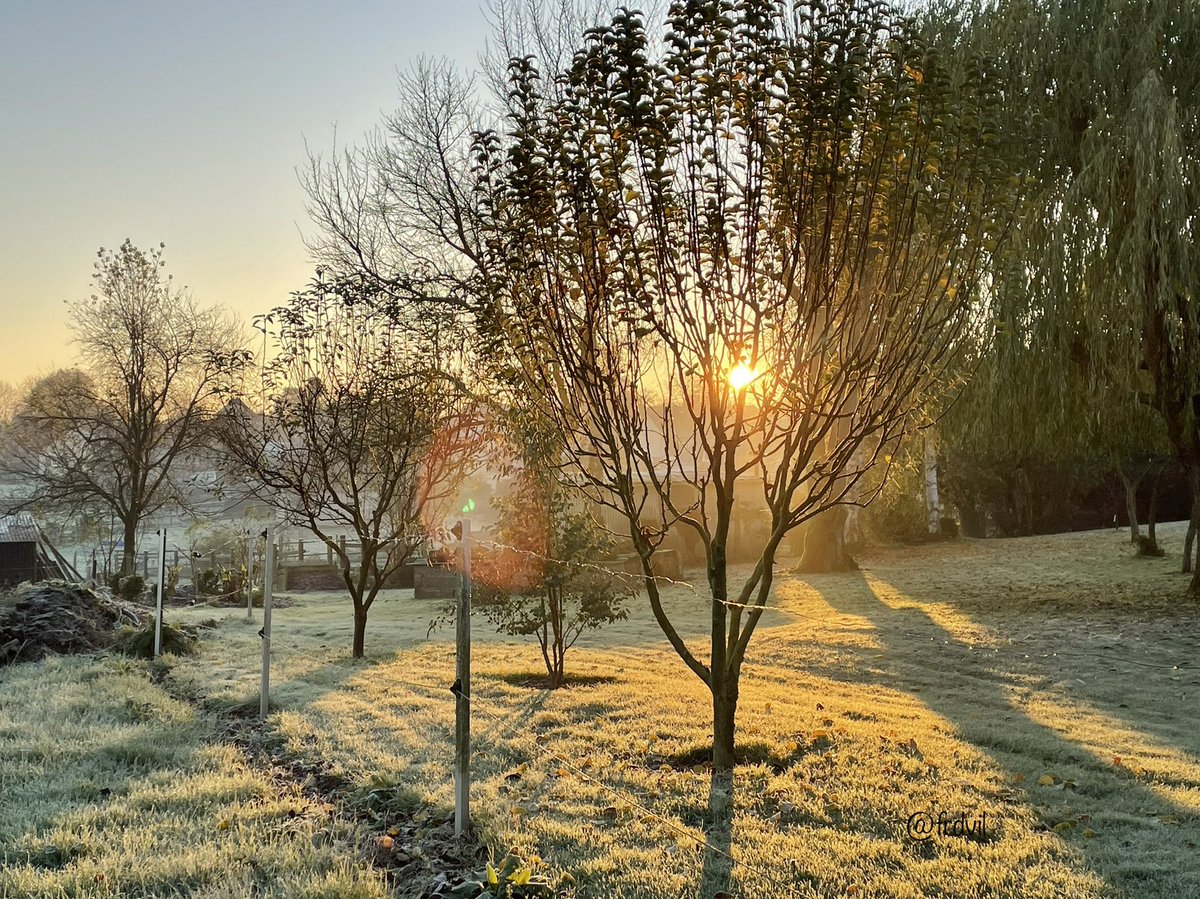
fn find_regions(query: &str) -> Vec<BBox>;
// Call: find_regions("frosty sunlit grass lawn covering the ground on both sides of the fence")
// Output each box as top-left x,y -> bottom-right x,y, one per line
0,525 -> 1200,899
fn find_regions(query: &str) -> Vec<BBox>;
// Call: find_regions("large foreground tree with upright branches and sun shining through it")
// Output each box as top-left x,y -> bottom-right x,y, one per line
478,0 -> 1009,771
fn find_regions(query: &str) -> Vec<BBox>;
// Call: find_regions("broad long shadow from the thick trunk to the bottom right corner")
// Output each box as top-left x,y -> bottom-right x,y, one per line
809,574 -> 1200,897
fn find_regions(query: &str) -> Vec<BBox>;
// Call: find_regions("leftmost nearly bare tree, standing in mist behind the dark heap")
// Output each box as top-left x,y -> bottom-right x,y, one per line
0,240 -> 246,575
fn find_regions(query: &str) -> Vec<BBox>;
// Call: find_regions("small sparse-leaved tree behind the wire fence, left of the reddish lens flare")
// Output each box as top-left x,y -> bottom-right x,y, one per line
221,280 -> 482,659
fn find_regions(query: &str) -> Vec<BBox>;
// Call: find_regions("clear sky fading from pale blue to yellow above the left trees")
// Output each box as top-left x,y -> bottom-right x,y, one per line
0,0 -> 490,382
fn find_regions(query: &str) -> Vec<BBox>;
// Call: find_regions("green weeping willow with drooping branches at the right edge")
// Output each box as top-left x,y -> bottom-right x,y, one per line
978,0 -> 1200,578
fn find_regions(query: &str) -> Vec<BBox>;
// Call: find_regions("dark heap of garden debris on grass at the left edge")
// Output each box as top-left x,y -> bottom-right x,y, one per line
0,581 -> 146,665
